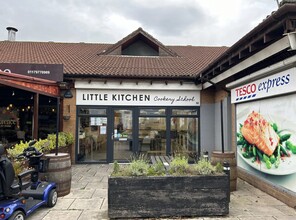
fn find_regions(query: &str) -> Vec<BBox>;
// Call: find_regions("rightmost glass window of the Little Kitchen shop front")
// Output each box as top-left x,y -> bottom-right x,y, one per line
170,109 -> 199,160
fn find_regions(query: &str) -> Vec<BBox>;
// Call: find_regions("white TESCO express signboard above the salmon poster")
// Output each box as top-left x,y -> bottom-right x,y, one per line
231,67 -> 296,103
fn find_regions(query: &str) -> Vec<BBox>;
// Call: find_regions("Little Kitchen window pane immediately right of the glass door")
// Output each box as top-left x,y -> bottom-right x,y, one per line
139,108 -> 166,155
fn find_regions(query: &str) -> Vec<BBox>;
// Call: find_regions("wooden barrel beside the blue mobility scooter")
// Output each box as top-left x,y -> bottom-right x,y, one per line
40,153 -> 72,196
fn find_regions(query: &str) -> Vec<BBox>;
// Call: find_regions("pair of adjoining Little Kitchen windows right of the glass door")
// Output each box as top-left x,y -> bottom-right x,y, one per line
138,108 -> 199,157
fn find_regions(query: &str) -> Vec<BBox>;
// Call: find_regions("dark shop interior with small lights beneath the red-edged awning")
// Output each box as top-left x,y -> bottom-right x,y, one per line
0,85 -> 57,147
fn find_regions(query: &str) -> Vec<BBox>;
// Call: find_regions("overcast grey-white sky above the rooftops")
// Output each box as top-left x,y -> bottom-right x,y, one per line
0,0 -> 278,46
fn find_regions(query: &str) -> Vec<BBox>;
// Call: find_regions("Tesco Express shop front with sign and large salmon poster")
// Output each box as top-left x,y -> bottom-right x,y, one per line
231,67 -> 296,196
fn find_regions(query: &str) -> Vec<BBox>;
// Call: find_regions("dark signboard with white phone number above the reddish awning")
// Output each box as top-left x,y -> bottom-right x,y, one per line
0,63 -> 64,82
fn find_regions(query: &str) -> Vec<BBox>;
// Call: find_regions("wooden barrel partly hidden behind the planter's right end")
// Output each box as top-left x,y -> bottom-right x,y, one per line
211,151 -> 237,192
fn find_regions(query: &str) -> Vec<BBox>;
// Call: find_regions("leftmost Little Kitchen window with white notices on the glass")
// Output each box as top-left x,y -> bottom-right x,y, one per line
77,108 -> 107,162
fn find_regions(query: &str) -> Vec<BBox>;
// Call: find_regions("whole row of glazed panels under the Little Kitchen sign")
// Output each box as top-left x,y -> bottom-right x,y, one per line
77,107 -> 199,162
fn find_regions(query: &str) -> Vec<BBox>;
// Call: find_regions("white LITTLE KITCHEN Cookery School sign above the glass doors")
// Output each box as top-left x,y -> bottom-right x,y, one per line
76,89 -> 200,106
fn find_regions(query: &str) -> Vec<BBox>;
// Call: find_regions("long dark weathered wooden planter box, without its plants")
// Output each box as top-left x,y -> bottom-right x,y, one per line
108,174 -> 229,218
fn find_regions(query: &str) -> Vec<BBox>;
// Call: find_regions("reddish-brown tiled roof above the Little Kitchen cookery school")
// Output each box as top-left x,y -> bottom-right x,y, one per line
0,41 -> 227,79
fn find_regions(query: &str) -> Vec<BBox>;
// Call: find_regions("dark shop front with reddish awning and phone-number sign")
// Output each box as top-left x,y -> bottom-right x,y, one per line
0,63 -> 63,147
